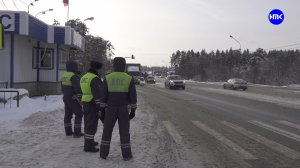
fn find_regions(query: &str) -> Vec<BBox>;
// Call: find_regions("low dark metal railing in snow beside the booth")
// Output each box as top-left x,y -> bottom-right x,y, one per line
0,89 -> 20,108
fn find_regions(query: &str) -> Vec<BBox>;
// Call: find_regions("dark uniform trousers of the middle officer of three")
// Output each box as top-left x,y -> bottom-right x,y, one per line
83,101 -> 98,148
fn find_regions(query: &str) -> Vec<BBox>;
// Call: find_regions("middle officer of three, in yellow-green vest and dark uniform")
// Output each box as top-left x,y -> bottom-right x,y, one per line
80,61 -> 102,152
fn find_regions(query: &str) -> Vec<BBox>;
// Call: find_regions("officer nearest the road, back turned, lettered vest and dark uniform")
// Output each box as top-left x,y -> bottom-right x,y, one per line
100,57 -> 137,161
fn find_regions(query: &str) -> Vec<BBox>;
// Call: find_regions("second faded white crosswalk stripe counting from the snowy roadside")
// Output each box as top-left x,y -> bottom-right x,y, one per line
192,121 -> 257,160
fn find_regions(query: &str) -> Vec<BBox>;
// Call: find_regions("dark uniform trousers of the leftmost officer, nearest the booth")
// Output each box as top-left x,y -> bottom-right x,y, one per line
63,96 -> 83,135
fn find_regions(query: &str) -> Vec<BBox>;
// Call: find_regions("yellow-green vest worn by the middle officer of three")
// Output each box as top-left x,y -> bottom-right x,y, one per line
80,72 -> 98,102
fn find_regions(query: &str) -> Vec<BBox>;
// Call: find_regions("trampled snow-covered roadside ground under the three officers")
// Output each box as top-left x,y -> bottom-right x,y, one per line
0,91 -> 178,168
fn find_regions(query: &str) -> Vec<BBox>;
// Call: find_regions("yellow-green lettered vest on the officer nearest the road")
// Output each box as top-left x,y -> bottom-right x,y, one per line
105,72 -> 132,92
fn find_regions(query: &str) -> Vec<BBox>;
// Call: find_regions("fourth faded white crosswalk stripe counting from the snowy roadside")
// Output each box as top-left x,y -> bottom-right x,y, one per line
249,120 -> 300,142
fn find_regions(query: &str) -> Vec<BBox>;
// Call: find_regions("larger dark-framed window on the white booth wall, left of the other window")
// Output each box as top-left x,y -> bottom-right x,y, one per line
32,48 -> 54,69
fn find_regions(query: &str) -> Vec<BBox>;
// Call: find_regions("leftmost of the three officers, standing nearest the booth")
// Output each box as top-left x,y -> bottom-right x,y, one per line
61,61 -> 83,138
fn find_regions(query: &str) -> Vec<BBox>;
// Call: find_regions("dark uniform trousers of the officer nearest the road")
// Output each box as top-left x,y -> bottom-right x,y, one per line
100,106 -> 132,158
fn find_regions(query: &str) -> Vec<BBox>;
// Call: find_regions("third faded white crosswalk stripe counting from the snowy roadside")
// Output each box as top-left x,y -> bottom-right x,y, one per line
222,121 -> 300,159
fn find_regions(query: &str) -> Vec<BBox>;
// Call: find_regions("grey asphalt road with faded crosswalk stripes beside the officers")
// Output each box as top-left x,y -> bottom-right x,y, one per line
138,79 -> 300,168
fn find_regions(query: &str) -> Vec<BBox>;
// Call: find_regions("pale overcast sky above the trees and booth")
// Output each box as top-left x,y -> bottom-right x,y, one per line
0,0 -> 300,66
